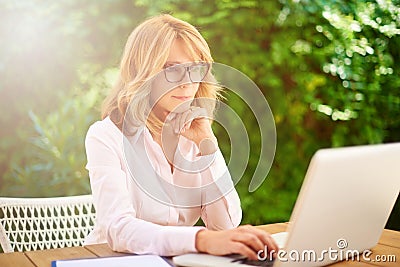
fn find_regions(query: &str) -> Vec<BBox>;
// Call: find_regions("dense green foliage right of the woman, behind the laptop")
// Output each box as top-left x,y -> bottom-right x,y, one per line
136,0 -> 400,227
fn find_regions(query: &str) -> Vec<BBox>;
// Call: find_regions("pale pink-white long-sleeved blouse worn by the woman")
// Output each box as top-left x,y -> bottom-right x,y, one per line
85,117 -> 242,256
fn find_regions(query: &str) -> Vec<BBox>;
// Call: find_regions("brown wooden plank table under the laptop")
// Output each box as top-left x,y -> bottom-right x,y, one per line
0,223 -> 400,267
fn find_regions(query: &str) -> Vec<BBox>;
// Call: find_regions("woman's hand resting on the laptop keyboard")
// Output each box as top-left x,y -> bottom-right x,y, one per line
196,225 -> 279,260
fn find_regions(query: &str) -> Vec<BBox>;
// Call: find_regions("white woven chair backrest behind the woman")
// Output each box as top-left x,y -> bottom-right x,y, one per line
0,195 -> 96,252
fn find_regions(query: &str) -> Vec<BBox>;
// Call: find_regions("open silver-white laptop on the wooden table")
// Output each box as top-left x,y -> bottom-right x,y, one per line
173,143 -> 400,267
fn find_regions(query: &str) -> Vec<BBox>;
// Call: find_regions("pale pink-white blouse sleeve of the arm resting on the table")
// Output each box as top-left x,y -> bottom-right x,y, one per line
85,124 -> 202,256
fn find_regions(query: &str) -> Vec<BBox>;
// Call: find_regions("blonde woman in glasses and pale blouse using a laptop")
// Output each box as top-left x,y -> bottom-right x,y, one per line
85,15 -> 277,259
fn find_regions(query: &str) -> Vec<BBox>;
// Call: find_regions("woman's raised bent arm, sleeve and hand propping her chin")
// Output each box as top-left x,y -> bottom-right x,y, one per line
170,107 -> 242,230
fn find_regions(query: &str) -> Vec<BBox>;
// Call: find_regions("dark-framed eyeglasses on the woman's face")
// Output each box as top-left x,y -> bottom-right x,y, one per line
164,62 -> 210,83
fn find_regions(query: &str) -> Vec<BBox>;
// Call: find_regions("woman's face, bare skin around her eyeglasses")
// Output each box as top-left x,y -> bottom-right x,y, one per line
150,39 -> 199,120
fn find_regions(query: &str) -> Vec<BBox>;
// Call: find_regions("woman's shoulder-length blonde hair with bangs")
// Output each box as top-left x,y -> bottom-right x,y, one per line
102,14 -> 221,133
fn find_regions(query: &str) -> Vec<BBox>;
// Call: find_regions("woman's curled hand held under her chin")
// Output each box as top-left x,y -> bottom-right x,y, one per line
169,107 -> 217,155
